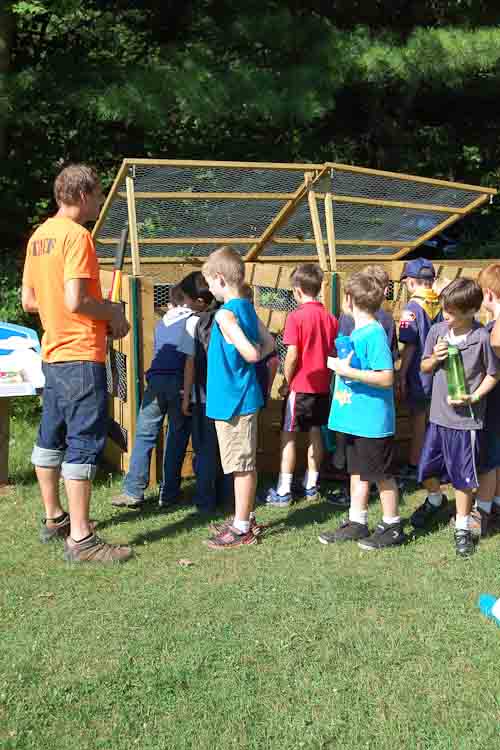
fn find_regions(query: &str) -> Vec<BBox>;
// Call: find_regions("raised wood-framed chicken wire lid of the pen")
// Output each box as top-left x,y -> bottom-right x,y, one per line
94,159 -> 495,260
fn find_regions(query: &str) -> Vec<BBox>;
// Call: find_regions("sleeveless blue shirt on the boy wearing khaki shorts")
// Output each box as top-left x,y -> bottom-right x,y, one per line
207,299 -> 264,421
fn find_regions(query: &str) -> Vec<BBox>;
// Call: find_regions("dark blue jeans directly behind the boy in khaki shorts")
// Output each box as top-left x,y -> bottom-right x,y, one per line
192,404 -> 233,512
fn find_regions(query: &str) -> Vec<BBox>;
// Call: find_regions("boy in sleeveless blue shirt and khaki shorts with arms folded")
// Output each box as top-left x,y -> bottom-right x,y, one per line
202,247 -> 274,549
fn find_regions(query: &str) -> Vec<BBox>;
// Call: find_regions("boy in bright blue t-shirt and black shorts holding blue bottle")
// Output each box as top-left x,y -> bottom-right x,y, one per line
319,271 -> 405,550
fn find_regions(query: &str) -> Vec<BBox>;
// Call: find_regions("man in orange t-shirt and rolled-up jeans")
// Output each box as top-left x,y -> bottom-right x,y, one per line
22,164 -> 132,562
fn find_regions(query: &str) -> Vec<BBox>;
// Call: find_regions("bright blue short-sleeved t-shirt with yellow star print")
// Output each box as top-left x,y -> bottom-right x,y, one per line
328,321 -> 396,438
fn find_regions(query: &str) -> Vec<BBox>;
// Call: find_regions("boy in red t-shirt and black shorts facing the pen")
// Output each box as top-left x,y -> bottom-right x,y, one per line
266,263 -> 338,507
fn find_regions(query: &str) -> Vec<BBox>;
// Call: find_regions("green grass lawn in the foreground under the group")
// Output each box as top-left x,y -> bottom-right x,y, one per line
0,421 -> 500,750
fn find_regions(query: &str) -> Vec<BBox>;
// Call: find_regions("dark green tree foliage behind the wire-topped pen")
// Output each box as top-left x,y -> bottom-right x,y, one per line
0,0 -> 500,286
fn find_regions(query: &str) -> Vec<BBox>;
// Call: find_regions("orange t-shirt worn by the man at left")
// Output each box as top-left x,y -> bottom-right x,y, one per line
23,217 -> 107,363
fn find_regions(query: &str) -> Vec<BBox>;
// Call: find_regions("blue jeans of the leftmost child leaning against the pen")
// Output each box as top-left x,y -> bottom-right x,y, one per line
123,373 -> 191,503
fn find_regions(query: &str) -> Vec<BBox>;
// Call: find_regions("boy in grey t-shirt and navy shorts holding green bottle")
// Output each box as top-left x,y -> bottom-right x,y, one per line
410,278 -> 500,556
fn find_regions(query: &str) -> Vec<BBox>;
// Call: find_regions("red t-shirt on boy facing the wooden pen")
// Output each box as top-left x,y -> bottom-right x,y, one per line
283,302 -> 339,393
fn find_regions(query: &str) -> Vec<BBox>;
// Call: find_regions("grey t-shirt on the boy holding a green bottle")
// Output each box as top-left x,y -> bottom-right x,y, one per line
422,320 -> 500,430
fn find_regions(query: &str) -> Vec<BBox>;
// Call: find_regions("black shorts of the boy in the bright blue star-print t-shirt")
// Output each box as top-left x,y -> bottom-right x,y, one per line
345,435 -> 394,482
